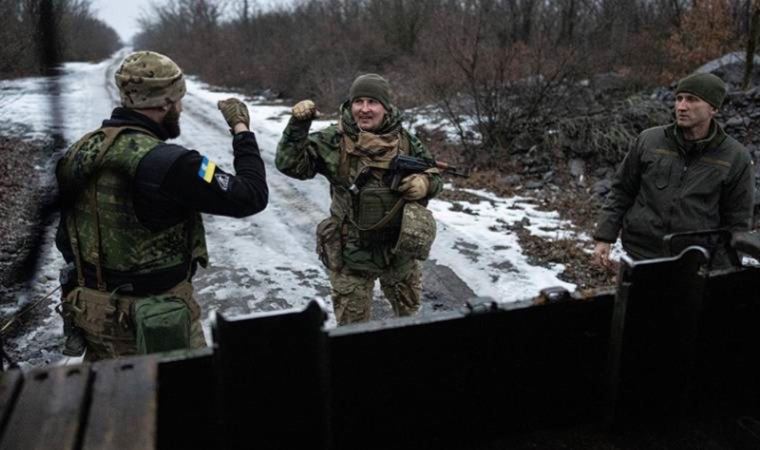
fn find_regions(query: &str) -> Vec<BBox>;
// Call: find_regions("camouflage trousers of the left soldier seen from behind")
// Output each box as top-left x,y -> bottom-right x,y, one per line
64,282 -> 206,361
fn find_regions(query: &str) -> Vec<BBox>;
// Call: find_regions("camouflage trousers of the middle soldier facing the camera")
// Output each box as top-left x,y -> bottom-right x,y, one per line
330,261 -> 422,325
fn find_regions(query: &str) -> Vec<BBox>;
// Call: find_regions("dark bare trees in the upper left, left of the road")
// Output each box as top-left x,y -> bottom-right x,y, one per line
0,0 -> 122,78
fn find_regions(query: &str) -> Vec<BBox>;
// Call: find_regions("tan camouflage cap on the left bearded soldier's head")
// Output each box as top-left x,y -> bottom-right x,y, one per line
114,51 -> 185,109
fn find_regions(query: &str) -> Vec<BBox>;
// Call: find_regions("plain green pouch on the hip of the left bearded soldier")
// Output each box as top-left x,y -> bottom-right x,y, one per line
132,295 -> 191,354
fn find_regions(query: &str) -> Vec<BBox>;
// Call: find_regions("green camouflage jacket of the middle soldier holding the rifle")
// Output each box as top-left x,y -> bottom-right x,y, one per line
275,103 -> 443,272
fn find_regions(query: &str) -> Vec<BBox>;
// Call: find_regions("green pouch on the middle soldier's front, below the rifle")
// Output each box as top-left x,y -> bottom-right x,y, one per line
355,187 -> 404,245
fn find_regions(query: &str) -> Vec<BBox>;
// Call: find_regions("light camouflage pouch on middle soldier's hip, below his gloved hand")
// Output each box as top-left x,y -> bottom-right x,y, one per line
393,202 -> 437,260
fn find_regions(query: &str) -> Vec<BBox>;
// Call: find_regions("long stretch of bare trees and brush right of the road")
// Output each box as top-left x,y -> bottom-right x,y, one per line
135,0 -> 760,162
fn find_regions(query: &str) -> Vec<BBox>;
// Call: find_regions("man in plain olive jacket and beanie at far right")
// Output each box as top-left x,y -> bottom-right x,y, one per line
593,73 -> 754,267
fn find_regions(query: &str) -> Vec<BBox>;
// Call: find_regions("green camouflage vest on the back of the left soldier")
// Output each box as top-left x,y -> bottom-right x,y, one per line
57,126 -> 208,290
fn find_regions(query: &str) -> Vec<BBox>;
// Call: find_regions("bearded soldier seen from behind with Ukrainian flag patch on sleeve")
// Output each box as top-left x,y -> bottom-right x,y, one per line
56,51 -> 268,360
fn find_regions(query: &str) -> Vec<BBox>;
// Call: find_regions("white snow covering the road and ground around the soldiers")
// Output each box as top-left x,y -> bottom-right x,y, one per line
0,51 -> 582,364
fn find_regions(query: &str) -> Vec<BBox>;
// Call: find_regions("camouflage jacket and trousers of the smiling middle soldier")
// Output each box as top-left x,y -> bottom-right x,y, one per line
275,102 -> 442,324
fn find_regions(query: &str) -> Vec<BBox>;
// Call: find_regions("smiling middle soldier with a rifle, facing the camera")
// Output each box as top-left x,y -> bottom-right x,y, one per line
275,74 -> 442,325
